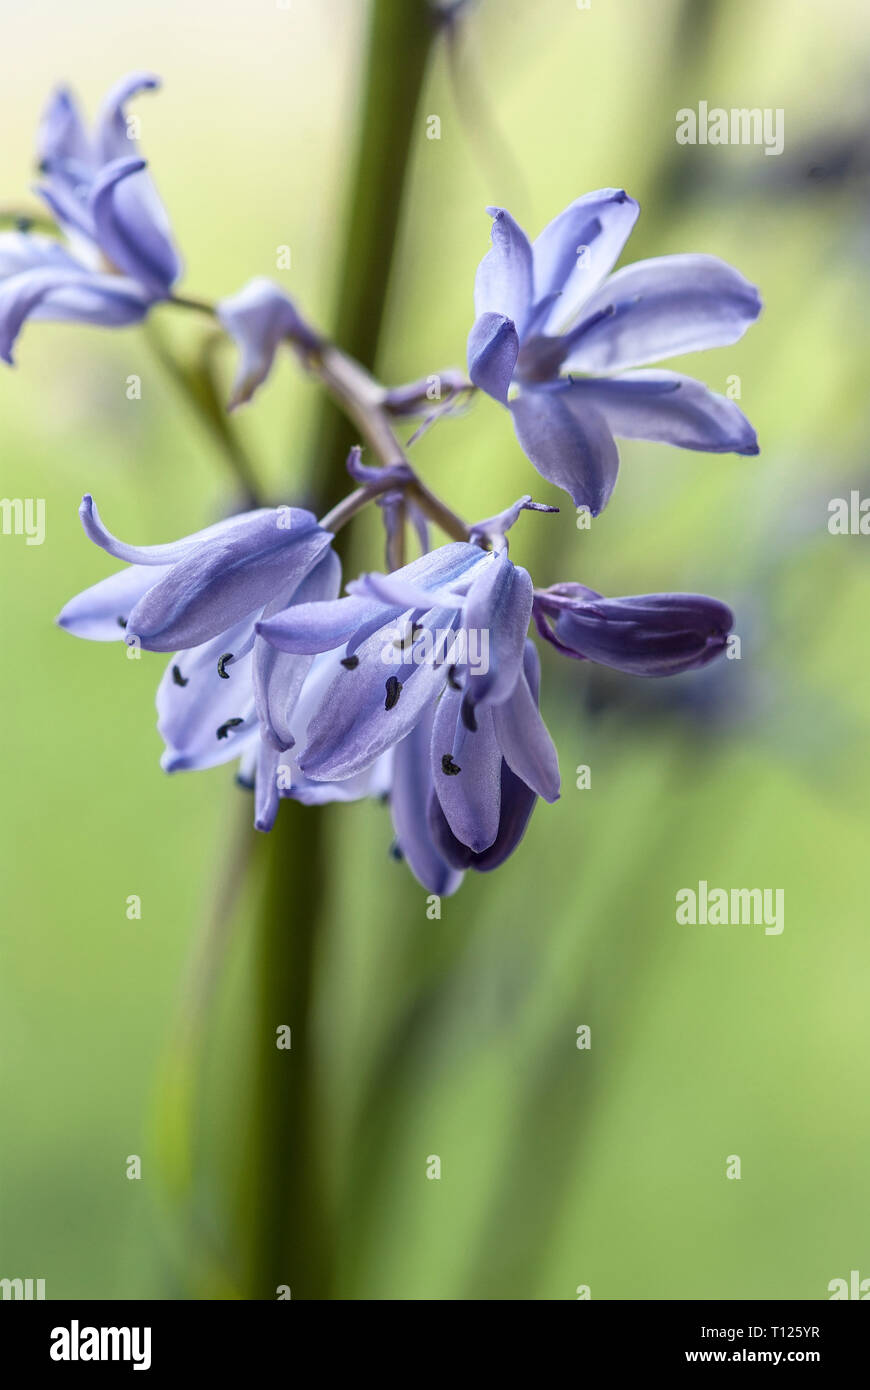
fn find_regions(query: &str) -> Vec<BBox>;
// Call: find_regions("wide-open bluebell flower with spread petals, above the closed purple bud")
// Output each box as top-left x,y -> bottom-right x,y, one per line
468,189 -> 762,516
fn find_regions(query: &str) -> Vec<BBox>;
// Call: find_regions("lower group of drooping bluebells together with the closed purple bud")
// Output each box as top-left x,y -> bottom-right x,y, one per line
58,496 -> 732,894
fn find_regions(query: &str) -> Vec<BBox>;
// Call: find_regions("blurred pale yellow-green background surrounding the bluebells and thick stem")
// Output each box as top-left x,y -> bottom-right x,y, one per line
0,0 -> 870,1300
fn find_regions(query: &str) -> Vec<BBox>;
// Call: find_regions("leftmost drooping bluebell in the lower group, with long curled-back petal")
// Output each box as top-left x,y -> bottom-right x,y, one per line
57,496 -> 334,828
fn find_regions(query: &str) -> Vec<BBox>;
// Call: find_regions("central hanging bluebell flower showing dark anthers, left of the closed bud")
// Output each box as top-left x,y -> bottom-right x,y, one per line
257,530 -> 559,892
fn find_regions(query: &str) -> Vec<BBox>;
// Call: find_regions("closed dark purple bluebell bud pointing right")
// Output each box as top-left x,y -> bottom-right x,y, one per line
534,584 -> 734,676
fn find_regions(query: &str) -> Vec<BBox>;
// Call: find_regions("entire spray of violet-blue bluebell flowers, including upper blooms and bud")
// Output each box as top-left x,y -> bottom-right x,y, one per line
0,74 -> 760,894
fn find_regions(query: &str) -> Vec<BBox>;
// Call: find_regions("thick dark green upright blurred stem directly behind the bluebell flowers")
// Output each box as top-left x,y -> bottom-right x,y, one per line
245,0 -> 436,1298
